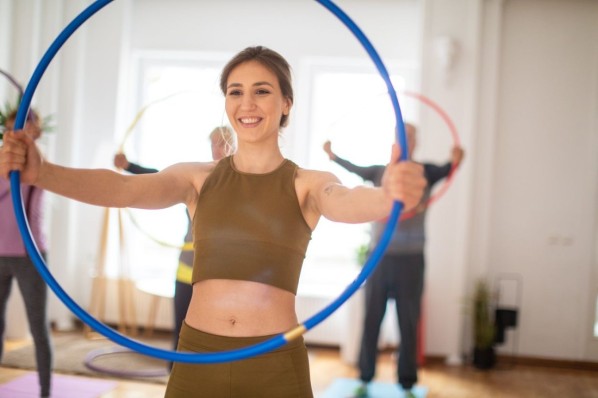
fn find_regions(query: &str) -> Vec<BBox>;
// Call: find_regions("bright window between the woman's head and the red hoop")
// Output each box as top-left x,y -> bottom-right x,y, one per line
302,60 -> 419,288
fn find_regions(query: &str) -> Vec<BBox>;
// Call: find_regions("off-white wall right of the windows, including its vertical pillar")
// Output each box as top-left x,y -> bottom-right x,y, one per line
422,0 -> 598,360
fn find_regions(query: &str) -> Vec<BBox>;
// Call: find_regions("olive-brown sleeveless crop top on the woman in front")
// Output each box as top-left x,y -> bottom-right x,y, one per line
192,156 -> 311,294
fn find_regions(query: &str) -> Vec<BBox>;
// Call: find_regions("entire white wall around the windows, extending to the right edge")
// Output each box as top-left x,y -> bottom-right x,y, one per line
0,0 -> 598,362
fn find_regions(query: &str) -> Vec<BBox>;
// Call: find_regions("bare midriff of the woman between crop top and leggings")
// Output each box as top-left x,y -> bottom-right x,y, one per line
185,279 -> 298,337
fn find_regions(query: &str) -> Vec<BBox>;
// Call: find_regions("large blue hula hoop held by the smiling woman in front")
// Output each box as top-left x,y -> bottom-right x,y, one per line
10,0 -> 407,363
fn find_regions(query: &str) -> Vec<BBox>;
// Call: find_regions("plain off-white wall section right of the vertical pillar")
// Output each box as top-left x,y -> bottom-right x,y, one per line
488,0 -> 598,359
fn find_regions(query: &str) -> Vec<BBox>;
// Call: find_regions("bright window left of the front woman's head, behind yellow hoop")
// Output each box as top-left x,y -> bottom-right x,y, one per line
108,53 -> 229,281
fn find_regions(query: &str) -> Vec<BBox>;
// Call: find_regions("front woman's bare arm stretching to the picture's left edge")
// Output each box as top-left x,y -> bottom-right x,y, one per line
0,131 -> 202,209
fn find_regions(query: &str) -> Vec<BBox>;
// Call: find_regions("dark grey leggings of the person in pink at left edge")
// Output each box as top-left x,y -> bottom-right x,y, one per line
0,257 -> 52,397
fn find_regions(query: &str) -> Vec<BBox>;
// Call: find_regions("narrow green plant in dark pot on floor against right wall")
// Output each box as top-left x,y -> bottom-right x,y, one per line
473,279 -> 496,369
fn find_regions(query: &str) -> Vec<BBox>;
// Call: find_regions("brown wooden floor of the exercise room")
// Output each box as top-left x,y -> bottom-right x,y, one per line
0,334 -> 598,398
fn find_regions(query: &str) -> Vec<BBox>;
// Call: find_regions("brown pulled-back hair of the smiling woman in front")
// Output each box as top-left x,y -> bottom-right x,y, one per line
220,46 -> 294,127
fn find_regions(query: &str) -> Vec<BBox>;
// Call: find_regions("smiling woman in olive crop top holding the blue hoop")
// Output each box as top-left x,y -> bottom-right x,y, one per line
0,46 -> 425,398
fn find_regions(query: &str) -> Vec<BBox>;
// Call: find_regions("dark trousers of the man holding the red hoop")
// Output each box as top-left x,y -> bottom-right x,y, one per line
359,253 -> 424,389
